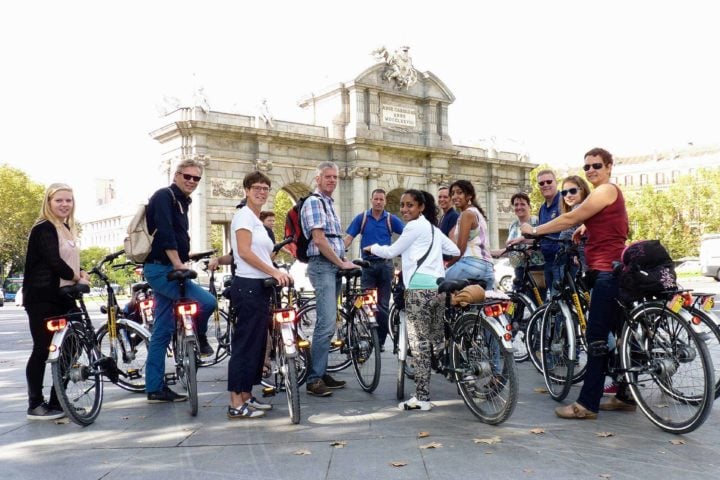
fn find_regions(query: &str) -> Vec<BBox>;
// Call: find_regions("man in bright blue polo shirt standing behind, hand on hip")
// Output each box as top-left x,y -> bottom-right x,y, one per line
344,188 -> 405,351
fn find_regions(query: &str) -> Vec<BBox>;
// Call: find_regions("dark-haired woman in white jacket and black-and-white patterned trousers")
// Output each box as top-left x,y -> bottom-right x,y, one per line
365,190 -> 460,410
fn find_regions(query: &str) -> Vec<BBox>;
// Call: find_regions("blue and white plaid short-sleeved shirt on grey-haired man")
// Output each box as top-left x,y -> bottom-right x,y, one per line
300,190 -> 345,258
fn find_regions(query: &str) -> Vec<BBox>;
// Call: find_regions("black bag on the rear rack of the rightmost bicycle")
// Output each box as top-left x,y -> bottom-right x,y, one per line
619,240 -> 677,303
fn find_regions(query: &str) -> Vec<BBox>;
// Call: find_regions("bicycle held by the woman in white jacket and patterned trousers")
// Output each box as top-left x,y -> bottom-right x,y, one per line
398,279 -> 518,425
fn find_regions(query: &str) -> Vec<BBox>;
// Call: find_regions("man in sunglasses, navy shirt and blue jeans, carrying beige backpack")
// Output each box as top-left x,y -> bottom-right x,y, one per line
143,160 -> 216,403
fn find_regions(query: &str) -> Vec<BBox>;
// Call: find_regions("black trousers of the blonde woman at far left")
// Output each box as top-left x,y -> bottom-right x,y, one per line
25,299 -> 75,408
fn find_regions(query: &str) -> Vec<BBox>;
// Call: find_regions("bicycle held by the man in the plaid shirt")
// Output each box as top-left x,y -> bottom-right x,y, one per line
298,260 -> 380,393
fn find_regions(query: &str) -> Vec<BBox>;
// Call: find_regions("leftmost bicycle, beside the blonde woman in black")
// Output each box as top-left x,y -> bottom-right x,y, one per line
46,250 -> 150,426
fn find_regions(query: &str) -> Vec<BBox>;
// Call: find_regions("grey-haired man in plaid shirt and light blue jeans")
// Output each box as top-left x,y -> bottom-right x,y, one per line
300,162 -> 358,397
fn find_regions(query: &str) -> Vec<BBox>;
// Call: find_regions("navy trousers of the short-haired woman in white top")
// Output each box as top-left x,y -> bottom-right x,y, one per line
228,277 -> 273,393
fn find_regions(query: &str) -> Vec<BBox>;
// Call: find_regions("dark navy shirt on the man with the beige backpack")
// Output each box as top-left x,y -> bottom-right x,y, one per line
145,183 -> 192,265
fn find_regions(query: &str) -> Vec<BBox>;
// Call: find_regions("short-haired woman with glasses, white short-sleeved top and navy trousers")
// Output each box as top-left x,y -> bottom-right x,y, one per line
227,172 -> 292,419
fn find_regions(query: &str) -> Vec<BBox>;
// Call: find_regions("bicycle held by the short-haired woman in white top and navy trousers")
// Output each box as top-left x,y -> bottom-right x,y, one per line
261,278 -> 310,424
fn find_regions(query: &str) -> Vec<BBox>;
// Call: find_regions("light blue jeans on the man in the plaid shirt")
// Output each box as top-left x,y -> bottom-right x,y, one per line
307,255 -> 342,385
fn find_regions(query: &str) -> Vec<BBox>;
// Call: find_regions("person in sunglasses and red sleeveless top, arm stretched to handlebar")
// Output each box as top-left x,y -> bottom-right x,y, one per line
520,148 -> 635,420
